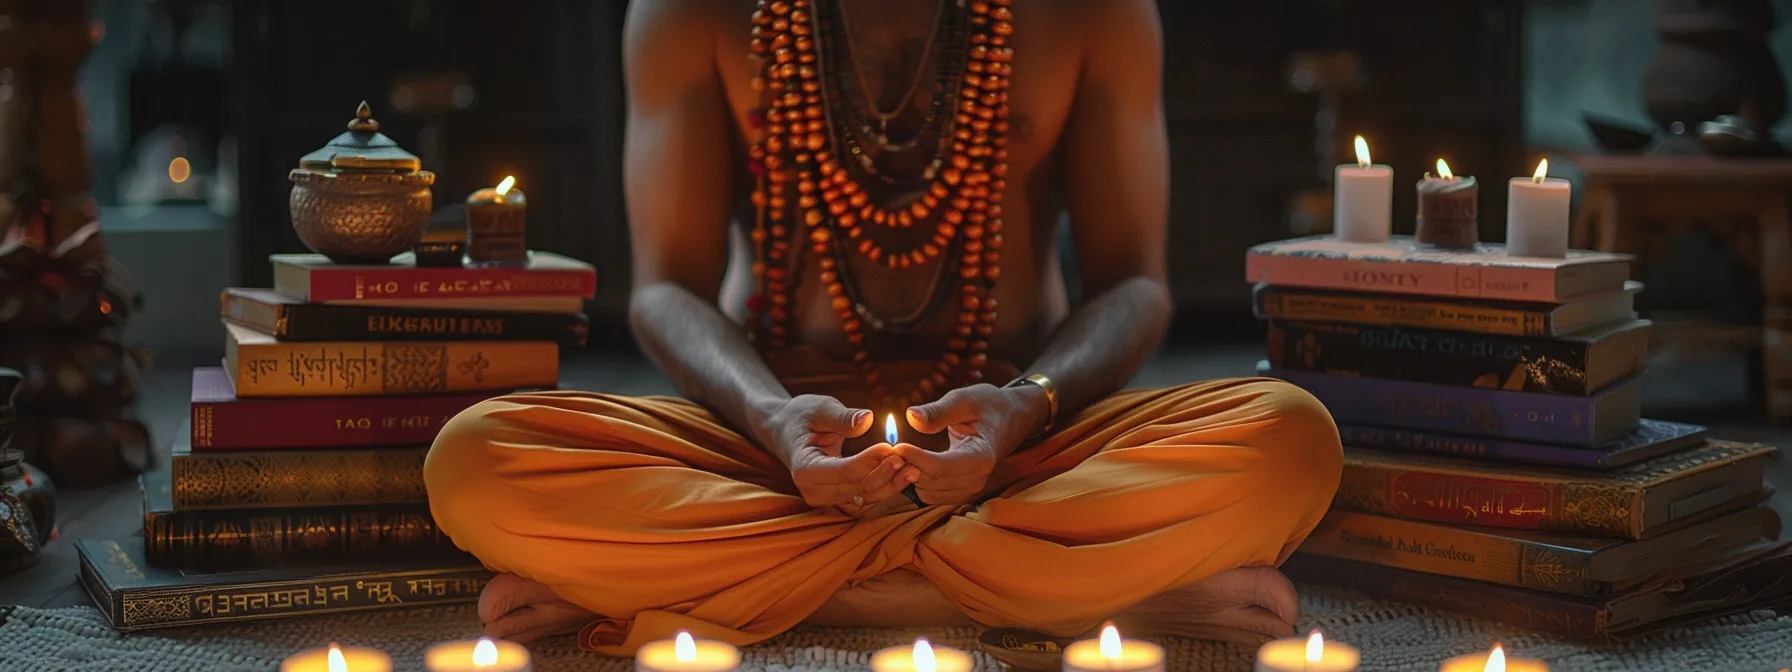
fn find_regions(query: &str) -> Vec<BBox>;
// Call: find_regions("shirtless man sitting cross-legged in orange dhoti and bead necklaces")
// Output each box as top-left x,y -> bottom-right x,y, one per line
425,0 -> 1342,654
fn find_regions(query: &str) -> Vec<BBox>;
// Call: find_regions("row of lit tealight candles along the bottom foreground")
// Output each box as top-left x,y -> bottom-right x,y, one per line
280,624 -> 1548,672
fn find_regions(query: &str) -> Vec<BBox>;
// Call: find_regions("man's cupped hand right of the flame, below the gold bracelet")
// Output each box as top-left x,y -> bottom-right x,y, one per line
896,383 -> 1050,504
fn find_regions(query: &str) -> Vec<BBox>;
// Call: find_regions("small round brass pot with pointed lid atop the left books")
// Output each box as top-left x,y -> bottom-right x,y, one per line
287,100 -> 435,265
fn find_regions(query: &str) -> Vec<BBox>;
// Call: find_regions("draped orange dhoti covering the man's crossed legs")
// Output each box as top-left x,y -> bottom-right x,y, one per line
425,378 -> 1342,654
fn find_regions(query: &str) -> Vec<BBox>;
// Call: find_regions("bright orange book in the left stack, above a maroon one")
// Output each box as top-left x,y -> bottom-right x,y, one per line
224,323 -> 559,398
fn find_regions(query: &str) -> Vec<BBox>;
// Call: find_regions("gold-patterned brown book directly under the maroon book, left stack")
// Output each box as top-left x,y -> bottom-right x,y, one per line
168,426 -> 430,511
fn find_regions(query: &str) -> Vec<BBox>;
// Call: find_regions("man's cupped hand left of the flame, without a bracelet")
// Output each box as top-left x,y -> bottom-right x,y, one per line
767,394 -> 909,507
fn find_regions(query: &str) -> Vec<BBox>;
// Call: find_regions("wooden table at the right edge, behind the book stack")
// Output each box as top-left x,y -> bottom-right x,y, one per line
1572,154 -> 1792,425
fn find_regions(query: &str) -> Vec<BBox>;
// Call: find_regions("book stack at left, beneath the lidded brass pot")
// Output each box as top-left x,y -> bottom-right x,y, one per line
77,253 -> 597,631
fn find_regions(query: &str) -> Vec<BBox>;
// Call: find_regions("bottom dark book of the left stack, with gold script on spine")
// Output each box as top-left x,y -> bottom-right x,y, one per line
75,538 -> 491,633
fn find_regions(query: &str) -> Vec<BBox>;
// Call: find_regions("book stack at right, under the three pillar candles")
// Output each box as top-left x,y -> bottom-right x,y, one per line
1247,237 -> 1792,640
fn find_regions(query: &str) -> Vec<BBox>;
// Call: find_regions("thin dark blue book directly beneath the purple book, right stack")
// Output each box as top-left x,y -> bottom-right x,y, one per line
1339,418 -> 1710,471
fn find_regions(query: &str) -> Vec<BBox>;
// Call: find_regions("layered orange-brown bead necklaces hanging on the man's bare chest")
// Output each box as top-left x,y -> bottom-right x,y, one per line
747,0 -> 1014,405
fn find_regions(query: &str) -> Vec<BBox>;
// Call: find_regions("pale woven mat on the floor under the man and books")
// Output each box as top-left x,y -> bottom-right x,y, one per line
0,588 -> 1792,672
